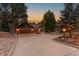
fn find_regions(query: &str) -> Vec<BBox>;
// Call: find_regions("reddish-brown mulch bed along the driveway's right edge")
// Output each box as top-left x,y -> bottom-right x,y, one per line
53,34 -> 79,49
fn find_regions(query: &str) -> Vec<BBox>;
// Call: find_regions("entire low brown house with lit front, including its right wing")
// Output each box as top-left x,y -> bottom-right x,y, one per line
16,22 -> 40,34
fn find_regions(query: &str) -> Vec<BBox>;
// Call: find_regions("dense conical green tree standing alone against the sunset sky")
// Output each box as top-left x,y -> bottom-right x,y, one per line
43,10 -> 56,32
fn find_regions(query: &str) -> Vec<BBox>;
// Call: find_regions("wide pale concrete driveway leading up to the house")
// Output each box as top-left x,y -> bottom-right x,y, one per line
13,33 -> 79,56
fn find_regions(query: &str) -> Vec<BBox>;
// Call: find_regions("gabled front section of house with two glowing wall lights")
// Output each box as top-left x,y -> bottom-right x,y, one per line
16,23 -> 35,34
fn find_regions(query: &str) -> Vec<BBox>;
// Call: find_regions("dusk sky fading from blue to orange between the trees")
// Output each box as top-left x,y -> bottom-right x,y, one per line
26,3 -> 64,23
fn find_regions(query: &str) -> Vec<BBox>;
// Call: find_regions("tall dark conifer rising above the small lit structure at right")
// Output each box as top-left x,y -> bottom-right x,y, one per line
60,3 -> 74,24
